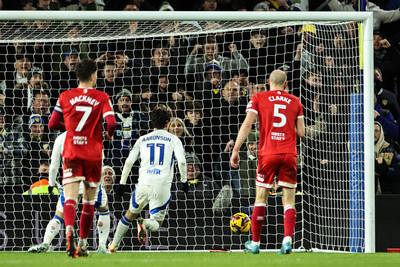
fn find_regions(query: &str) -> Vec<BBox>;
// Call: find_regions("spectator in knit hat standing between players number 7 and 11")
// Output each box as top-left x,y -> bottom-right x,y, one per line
104,89 -> 149,177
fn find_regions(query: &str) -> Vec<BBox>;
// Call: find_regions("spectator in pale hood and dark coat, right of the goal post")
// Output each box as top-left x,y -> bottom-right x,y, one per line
374,121 -> 400,194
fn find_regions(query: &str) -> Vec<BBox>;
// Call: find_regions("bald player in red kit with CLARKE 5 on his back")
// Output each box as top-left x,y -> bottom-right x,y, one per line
230,70 -> 305,254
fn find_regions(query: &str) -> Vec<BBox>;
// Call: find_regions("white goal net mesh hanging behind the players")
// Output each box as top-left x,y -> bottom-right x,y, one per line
0,18 -> 363,251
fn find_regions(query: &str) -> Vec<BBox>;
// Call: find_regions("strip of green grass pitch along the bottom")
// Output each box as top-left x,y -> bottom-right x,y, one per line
0,252 -> 400,267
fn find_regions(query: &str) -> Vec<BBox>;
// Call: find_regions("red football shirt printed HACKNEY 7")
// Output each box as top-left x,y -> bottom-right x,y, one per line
54,88 -> 114,161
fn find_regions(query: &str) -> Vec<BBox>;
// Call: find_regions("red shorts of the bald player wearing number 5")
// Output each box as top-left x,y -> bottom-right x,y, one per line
256,154 -> 297,188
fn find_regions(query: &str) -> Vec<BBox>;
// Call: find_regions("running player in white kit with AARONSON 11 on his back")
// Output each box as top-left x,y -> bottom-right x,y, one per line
108,107 -> 187,252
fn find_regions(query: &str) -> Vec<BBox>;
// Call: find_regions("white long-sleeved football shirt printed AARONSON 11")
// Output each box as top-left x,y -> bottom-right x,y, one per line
120,130 -> 186,185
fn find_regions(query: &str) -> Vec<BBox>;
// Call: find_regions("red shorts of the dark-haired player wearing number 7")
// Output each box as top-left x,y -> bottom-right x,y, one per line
63,159 -> 102,187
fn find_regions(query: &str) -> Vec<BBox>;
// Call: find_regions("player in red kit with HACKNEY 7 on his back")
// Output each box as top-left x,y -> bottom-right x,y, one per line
49,59 -> 116,258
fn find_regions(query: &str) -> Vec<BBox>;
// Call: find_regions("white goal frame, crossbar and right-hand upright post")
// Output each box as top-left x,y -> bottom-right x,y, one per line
0,11 -> 375,253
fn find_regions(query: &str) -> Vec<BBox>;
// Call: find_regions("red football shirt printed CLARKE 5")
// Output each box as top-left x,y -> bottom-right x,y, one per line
246,90 -> 303,156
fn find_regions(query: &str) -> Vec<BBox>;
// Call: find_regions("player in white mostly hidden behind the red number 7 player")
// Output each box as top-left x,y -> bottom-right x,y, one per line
28,132 -> 115,253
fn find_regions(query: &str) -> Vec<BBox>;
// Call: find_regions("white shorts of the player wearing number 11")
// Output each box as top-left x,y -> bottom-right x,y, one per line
129,184 -> 172,221
